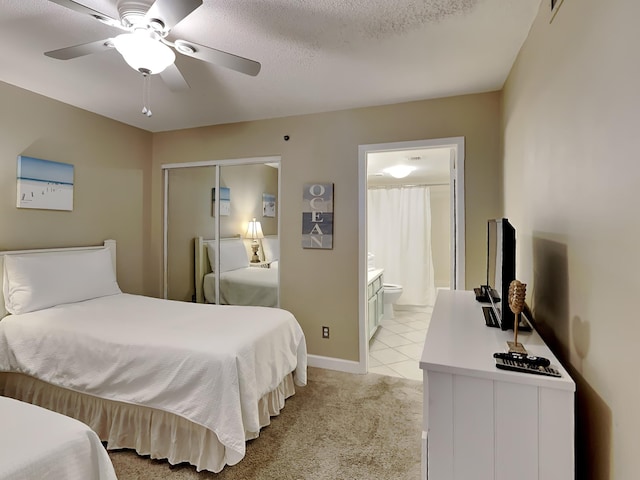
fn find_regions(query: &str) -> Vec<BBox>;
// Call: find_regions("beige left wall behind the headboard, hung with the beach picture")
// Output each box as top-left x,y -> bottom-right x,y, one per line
0,82 -> 151,293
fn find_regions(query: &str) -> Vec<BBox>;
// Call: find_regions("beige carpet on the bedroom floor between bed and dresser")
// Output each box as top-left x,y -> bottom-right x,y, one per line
109,368 -> 422,480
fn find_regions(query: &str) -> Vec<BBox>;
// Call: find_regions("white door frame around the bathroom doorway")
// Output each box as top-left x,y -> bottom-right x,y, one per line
358,137 -> 465,373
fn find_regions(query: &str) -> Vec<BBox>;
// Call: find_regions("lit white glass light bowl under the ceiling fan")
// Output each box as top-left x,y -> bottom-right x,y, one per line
113,29 -> 176,74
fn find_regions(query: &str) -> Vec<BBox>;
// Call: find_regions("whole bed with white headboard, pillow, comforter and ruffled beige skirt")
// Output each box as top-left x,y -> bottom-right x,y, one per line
0,241 -> 306,472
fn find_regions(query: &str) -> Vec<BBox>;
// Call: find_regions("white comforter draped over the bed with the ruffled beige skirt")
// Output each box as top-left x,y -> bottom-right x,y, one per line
0,294 -> 306,465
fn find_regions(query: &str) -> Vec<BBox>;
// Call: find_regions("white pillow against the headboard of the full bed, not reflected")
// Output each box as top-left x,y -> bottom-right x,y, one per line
3,248 -> 122,314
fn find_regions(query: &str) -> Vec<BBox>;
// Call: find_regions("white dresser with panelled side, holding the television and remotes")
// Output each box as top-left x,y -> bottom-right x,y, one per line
420,290 -> 575,480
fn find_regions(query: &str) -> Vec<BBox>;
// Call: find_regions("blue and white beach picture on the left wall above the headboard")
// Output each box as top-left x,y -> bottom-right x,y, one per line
17,155 -> 73,211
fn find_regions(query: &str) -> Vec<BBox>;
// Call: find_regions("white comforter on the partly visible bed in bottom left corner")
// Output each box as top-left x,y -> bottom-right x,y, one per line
0,397 -> 116,480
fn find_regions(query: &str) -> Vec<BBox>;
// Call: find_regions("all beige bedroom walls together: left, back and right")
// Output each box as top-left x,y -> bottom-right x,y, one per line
5,0 -> 640,468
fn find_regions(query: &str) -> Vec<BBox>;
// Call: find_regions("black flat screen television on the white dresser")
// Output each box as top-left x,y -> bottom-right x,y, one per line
487,218 -> 516,330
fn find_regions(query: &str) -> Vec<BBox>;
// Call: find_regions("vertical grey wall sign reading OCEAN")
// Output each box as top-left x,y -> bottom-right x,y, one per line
302,183 -> 333,249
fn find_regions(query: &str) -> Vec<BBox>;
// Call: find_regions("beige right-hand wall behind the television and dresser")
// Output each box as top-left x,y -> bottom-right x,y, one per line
503,0 -> 640,480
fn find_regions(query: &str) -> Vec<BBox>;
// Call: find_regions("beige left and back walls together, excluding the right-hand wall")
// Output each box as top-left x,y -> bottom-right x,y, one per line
0,83 -> 502,360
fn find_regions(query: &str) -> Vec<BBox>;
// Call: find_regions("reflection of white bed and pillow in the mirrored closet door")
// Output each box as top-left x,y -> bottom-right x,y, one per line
195,236 -> 279,307
